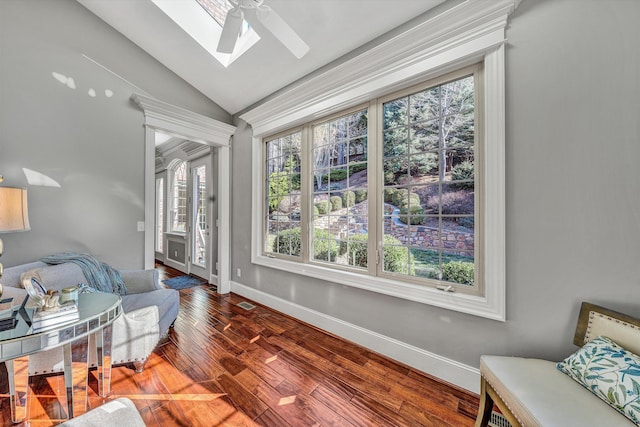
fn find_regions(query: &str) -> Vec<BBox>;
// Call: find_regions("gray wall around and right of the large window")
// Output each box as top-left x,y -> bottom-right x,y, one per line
232,0 -> 640,372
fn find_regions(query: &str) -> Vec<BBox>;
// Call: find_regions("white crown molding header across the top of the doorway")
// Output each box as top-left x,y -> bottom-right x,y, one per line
131,93 -> 236,146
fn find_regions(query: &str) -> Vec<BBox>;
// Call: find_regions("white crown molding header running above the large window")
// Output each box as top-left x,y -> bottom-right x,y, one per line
240,0 -> 521,136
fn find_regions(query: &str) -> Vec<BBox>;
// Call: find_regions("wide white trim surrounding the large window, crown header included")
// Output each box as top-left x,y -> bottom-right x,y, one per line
240,0 -> 520,321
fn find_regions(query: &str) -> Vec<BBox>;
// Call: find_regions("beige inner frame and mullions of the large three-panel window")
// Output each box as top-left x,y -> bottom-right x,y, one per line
260,64 -> 484,295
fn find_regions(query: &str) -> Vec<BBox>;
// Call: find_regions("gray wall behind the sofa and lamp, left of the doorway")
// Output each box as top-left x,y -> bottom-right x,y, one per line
0,0 -> 231,268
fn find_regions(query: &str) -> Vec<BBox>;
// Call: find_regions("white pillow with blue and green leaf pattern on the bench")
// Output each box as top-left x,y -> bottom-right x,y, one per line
557,336 -> 640,426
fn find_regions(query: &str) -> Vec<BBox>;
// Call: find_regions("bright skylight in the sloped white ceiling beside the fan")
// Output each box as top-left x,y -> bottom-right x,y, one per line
151,0 -> 260,67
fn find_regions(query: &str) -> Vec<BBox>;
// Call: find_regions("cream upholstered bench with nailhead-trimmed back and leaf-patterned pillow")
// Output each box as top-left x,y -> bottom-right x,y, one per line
476,303 -> 640,427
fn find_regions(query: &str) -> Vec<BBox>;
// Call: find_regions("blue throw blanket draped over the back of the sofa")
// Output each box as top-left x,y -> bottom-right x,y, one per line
41,253 -> 127,295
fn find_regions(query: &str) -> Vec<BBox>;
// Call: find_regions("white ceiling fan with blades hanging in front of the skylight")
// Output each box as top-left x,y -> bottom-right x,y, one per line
216,0 -> 309,59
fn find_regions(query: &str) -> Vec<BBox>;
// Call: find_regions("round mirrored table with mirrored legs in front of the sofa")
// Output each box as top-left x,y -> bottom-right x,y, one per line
0,292 -> 122,423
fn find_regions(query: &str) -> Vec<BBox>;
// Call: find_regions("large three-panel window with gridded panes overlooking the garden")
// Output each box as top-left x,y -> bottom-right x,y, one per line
263,66 -> 482,294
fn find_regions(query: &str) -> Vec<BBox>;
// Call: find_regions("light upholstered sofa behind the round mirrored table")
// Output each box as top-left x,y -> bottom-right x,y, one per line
0,261 -> 180,375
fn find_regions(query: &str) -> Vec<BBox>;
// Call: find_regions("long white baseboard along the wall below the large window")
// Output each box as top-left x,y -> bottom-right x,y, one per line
231,281 -> 480,394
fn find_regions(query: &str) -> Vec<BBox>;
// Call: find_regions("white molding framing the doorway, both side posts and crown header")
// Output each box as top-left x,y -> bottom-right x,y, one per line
131,93 -> 236,294
